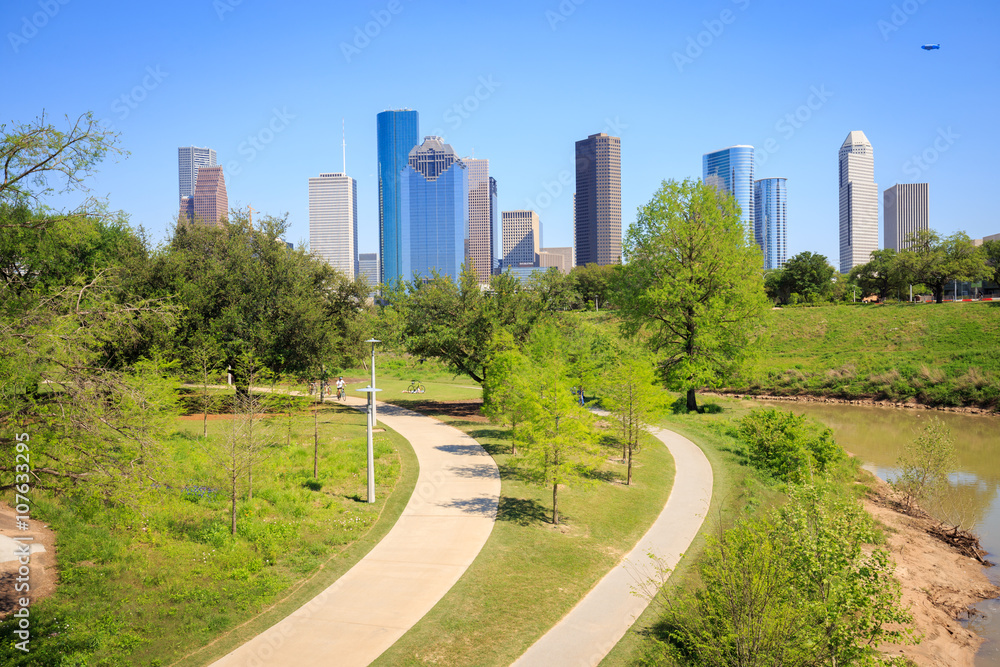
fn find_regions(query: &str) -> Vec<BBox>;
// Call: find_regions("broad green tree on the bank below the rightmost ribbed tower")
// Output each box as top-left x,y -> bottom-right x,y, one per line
899,229 -> 988,303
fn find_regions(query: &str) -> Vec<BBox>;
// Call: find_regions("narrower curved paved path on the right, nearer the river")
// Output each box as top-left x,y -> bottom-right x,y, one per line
514,422 -> 712,667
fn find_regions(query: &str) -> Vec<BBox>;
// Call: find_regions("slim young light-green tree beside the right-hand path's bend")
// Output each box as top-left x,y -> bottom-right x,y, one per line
601,356 -> 665,485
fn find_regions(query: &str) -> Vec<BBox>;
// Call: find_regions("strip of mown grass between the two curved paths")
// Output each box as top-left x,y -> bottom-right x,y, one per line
374,392 -> 674,666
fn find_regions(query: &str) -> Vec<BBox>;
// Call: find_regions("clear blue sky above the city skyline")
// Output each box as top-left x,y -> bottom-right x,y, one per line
0,0 -> 1000,265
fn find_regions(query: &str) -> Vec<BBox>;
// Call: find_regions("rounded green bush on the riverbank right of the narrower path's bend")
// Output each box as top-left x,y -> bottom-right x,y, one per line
738,408 -> 845,482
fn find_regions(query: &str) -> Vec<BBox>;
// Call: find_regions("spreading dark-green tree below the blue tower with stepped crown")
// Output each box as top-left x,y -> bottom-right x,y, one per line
393,266 -> 541,384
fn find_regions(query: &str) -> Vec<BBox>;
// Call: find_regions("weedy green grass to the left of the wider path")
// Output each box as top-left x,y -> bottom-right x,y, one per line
0,405 -> 417,667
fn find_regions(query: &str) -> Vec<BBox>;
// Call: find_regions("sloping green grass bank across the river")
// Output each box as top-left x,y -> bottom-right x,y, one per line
730,303 -> 1000,409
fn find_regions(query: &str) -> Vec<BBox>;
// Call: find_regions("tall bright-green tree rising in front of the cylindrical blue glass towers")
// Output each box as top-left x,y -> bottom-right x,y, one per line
613,180 -> 768,410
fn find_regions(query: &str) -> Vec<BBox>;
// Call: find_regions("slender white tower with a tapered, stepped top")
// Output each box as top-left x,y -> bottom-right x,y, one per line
840,130 -> 878,273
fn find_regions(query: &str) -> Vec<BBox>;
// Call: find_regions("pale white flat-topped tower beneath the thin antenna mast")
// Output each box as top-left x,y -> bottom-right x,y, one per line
309,173 -> 358,280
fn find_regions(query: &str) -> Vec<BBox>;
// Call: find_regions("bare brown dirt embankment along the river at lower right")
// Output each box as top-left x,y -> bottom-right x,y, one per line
865,480 -> 1000,667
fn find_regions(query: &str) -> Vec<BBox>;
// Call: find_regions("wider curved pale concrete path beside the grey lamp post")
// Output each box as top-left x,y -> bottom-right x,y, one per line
213,396 -> 500,667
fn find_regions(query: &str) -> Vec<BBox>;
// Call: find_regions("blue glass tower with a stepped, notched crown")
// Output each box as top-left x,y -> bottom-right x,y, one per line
398,136 -> 469,279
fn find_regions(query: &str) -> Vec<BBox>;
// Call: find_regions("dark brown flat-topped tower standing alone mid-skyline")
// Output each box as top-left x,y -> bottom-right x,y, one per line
573,132 -> 622,266
